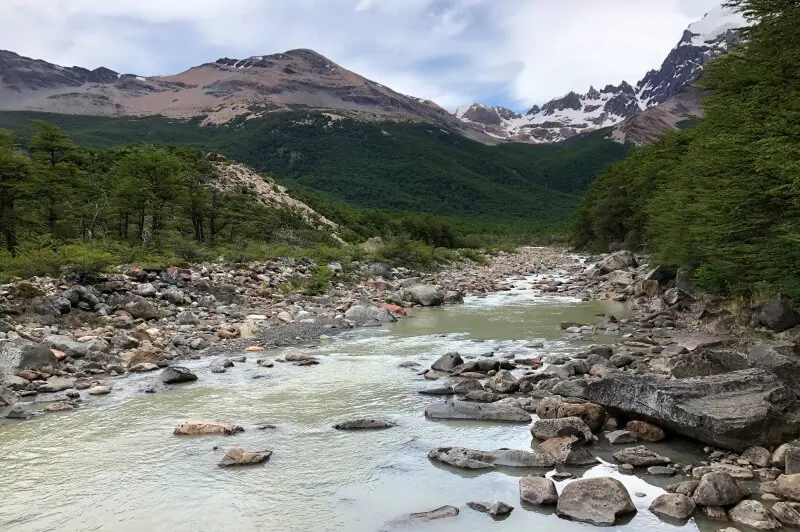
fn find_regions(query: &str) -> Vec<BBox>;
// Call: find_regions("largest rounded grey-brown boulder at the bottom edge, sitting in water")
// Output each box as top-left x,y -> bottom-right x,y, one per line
556,477 -> 636,526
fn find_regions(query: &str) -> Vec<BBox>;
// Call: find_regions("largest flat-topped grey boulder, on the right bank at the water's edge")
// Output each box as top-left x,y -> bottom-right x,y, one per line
586,369 -> 794,452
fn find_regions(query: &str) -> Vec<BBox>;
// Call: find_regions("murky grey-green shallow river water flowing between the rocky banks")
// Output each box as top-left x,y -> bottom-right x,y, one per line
0,276 -> 720,532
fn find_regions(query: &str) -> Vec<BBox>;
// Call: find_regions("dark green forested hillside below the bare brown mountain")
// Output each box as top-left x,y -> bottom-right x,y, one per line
0,112 -> 627,222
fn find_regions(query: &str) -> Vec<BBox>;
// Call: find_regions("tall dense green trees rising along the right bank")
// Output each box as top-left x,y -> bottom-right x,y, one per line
572,0 -> 800,298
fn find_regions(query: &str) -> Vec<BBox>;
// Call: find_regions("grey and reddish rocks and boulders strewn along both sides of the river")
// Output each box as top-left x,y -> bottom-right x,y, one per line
0,248 -> 800,530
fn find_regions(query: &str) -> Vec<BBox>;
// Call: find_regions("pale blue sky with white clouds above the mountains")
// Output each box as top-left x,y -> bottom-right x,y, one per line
0,0 -> 721,110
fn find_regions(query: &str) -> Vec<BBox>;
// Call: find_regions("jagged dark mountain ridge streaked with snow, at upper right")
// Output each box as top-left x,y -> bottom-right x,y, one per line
455,6 -> 747,143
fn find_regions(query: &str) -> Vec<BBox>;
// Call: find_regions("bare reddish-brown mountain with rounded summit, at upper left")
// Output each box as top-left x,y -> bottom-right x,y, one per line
0,49 -> 478,135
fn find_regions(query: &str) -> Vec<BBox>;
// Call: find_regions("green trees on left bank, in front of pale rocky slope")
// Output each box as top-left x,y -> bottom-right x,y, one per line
0,121 -> 336,264
